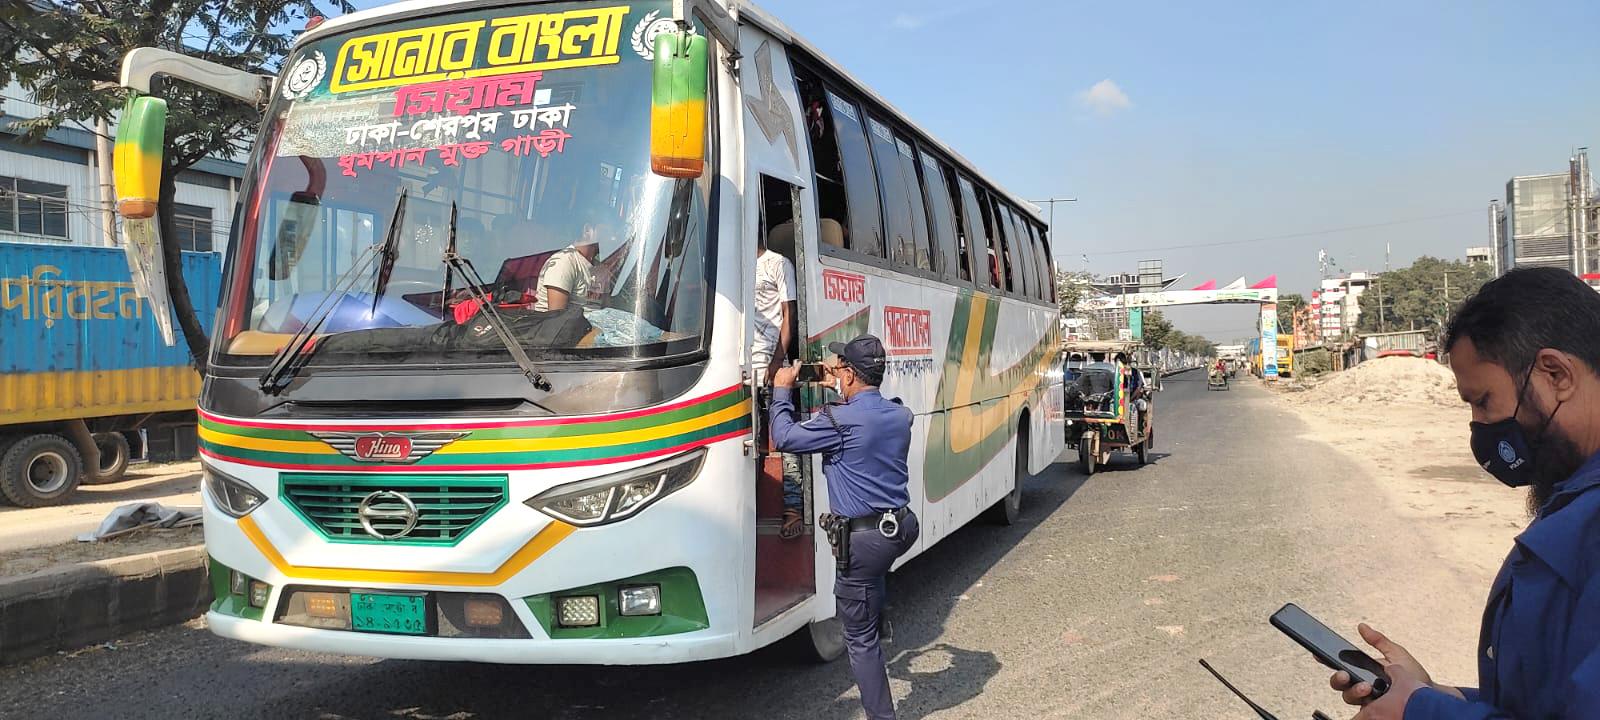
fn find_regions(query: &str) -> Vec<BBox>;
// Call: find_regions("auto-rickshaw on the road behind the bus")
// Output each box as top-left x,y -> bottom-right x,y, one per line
1066,342 -> 1158,475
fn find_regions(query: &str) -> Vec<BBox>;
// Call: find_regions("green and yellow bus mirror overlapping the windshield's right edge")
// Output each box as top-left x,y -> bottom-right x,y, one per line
650,32 -> 707,178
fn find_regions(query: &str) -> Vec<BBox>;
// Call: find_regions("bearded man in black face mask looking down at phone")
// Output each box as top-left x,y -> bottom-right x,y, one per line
1331,267 -> 1600,720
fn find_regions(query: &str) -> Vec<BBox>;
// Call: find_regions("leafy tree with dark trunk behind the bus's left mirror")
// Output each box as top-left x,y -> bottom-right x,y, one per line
0,0 -> 355,370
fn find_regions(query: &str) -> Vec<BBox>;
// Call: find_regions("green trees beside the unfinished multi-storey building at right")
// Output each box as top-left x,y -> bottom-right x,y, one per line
1357,256 -> 1493,334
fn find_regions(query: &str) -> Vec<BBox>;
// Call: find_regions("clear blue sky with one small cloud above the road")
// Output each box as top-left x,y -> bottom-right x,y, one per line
340,0 -> 1600,339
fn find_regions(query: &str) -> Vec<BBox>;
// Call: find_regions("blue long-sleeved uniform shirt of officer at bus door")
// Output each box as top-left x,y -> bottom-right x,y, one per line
770,387 -> 912,517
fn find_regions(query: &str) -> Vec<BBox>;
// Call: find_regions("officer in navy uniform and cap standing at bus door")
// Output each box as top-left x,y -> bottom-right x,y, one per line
771,334 -> 922,720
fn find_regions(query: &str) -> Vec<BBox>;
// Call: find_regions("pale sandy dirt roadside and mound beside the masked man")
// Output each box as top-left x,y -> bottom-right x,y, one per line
1278,358 -> 1530,579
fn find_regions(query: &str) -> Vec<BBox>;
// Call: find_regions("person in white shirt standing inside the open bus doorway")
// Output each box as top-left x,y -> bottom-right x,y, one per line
750,233 -> 805,541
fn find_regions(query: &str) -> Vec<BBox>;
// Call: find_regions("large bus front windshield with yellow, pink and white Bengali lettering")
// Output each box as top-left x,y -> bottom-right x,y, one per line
219,2 -> 710,366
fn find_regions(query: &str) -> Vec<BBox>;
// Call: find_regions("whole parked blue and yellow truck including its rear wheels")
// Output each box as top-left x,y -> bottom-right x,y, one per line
0,242 -> 221,507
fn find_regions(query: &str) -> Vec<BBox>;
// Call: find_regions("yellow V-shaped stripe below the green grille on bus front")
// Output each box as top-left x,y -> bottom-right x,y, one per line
238,515 -> 578,587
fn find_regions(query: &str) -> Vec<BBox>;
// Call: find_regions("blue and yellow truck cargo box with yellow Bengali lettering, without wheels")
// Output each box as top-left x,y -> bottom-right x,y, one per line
0,243 -> 222,427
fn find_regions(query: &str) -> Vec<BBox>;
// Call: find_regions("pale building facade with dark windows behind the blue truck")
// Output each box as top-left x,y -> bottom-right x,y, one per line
0,83 -> 243,251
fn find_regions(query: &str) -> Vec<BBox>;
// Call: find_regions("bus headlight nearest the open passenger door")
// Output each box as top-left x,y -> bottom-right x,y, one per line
525,448 -> 706,526
